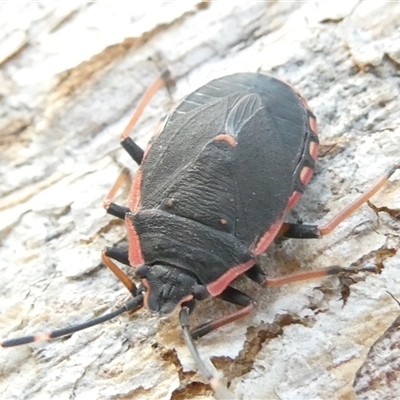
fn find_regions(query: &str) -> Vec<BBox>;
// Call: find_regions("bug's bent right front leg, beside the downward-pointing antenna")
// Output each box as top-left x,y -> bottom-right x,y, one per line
191,286 -> 255,339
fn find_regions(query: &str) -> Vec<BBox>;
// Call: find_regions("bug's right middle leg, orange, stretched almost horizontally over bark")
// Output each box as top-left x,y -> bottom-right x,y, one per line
246,265 -> 377,287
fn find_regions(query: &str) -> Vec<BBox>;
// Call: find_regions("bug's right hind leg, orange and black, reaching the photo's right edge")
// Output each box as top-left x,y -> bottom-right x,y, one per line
278,164 -> 400,239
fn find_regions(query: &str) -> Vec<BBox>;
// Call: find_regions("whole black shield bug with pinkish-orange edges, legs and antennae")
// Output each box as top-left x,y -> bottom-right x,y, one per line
1,73 -> 399,398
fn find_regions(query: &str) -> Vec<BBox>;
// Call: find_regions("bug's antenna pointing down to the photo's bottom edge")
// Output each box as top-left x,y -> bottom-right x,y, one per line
179,306 -> 236,400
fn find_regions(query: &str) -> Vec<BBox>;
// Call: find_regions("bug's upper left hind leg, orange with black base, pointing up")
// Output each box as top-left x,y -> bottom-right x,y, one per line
120,70 -> 174,165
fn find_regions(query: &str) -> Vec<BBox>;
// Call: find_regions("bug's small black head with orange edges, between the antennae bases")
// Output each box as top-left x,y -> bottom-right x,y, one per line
135,264 -> 208,315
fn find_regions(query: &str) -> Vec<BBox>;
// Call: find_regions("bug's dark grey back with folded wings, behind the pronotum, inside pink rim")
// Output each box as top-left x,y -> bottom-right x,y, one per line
141,74 -> 309,247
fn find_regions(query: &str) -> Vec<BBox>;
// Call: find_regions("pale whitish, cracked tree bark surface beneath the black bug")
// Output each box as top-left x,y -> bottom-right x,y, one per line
0,0 -> 400,400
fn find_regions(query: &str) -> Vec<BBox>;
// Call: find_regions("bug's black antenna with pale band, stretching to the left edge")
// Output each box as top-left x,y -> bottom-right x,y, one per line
0,294 -> 143,347
